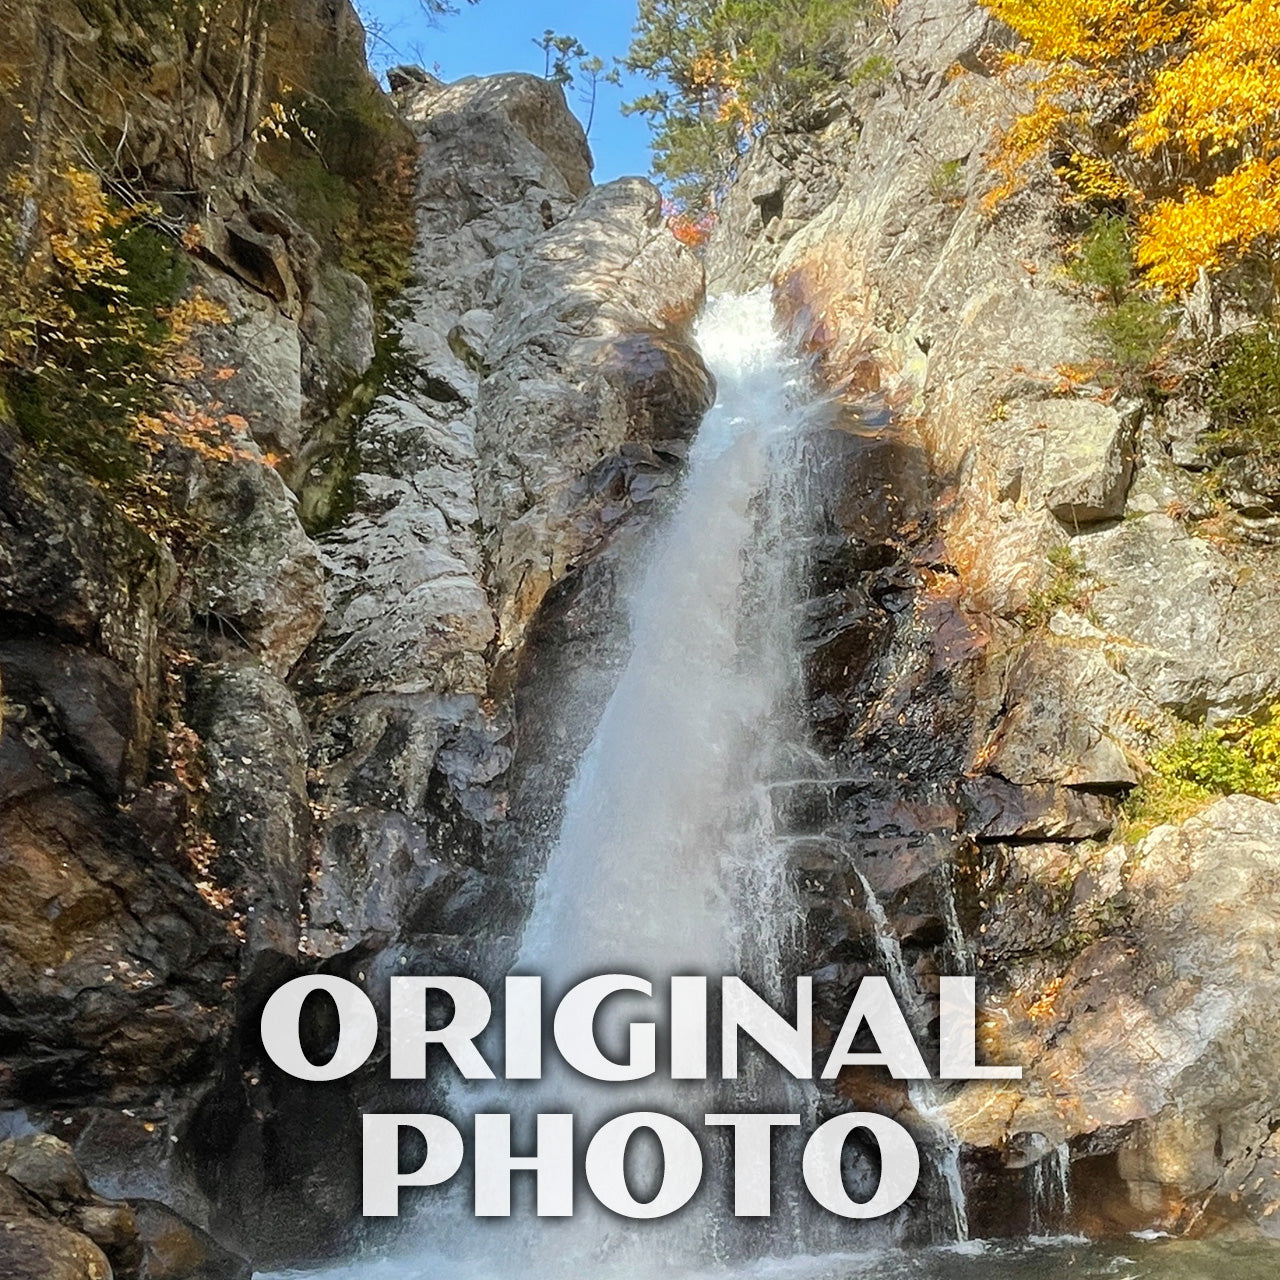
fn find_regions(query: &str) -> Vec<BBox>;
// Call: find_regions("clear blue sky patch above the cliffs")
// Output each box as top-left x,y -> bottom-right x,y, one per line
356,0 -> 649,182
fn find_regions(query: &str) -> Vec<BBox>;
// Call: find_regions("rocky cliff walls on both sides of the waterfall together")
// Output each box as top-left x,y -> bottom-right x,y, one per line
10,0 -> 1280,1276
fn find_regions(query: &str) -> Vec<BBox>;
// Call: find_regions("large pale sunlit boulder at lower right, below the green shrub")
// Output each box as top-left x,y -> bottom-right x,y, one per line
946,796 -> 1280,1226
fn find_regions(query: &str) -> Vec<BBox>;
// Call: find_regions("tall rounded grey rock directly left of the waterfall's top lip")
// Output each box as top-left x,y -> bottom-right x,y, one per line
477,179 -> 712,650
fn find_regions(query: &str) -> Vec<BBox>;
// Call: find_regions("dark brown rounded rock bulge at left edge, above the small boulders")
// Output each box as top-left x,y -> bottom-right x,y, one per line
0,778 -> 236,1105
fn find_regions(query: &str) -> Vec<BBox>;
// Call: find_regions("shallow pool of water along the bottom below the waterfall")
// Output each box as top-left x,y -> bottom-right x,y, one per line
262,1236 -> 1280,1280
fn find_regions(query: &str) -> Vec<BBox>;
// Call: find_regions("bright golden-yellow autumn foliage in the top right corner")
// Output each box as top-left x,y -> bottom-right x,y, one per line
988,0 -> 1280,298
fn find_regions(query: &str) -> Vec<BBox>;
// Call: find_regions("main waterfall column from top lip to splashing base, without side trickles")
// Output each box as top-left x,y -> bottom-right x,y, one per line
268,292 -> 824,1280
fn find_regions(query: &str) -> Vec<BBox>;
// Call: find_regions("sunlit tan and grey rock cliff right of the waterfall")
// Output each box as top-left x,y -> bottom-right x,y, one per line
709,0 -> 1280,1233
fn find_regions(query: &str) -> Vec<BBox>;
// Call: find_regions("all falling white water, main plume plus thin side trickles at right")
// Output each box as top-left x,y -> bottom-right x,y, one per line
249,296 -> 1271,1280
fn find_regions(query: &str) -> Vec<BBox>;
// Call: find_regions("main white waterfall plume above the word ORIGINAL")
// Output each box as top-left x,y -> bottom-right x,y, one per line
517,292 -> 799,995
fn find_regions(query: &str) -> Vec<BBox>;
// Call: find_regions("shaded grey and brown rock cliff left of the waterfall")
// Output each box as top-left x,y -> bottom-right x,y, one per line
0,4 -> 710,1276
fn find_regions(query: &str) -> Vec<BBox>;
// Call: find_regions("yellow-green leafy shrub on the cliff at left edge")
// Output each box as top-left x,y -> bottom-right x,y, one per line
0,165 -> 244,500
